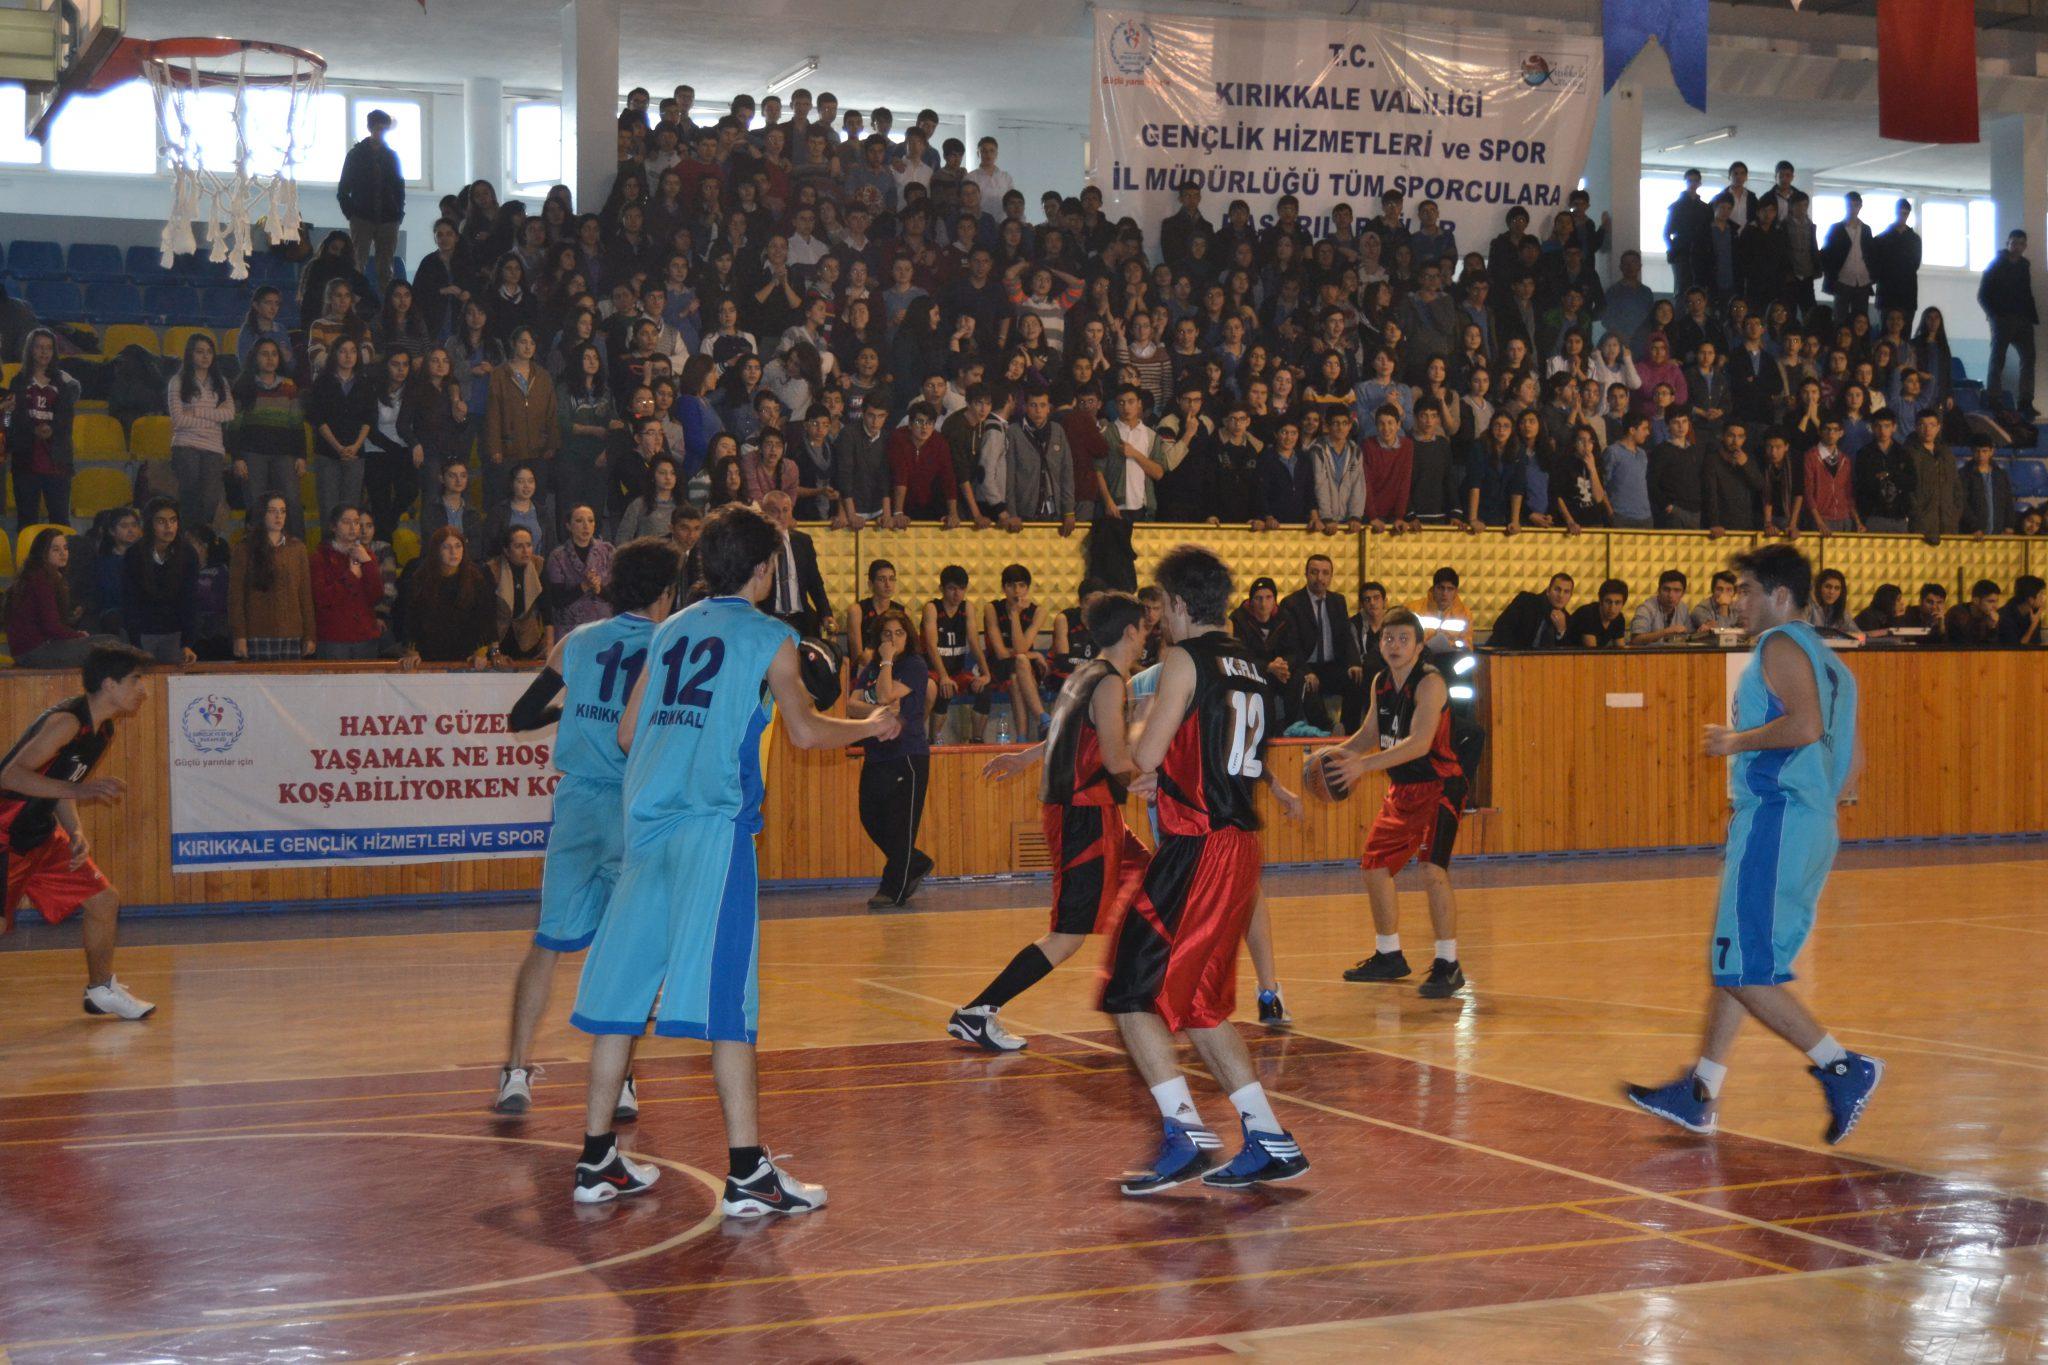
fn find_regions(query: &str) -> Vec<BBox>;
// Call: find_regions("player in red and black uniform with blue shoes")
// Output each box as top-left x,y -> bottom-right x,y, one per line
1102,544 -> 1309,1195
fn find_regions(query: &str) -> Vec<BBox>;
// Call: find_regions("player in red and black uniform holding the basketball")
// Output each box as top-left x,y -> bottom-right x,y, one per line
1311,608 -> 1464,1001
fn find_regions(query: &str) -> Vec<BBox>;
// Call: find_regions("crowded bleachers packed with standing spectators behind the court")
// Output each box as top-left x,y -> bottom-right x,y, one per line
0,86 -> 2048,712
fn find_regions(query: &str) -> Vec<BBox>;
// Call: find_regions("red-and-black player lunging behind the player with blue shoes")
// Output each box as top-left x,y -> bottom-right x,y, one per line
946,593 -> 1151,1052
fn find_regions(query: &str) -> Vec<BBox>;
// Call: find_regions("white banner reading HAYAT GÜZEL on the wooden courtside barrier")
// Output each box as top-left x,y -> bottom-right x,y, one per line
168,673 -> 557,872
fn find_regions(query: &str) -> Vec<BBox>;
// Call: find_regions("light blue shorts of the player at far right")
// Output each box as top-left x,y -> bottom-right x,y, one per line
1708,800 -> 1839,986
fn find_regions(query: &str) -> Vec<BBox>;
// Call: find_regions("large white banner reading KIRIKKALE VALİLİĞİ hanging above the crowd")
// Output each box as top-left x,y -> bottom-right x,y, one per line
1092,10 -> 1599,252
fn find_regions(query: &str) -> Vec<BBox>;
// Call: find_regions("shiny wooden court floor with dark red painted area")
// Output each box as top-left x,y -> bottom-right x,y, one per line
0,845 -> 2048,1363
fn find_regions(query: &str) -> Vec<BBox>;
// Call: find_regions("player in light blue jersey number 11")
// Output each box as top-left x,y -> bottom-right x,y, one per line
492,536 -> 682,1121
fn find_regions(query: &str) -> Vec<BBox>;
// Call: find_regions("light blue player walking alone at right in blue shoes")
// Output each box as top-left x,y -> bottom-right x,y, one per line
1624,544 -> 1884,1144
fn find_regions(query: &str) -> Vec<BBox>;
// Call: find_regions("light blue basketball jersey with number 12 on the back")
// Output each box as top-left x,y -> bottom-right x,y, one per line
625,598 -> 797,847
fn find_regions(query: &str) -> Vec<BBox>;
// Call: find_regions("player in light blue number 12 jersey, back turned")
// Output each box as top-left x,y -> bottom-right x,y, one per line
569,505 -> 899,1218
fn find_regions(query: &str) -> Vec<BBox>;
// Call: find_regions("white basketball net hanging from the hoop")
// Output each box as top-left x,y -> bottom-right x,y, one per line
143,49 -> 326,280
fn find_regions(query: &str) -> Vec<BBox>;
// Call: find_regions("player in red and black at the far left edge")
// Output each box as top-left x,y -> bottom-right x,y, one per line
0,645 -> 156,1019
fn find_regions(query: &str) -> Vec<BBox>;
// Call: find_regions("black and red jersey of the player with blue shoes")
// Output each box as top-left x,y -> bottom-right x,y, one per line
1159,630 -> 1274,835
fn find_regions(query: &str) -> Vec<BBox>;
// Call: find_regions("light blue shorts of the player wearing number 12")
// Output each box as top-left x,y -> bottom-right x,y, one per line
569,817 -> 760,1042
